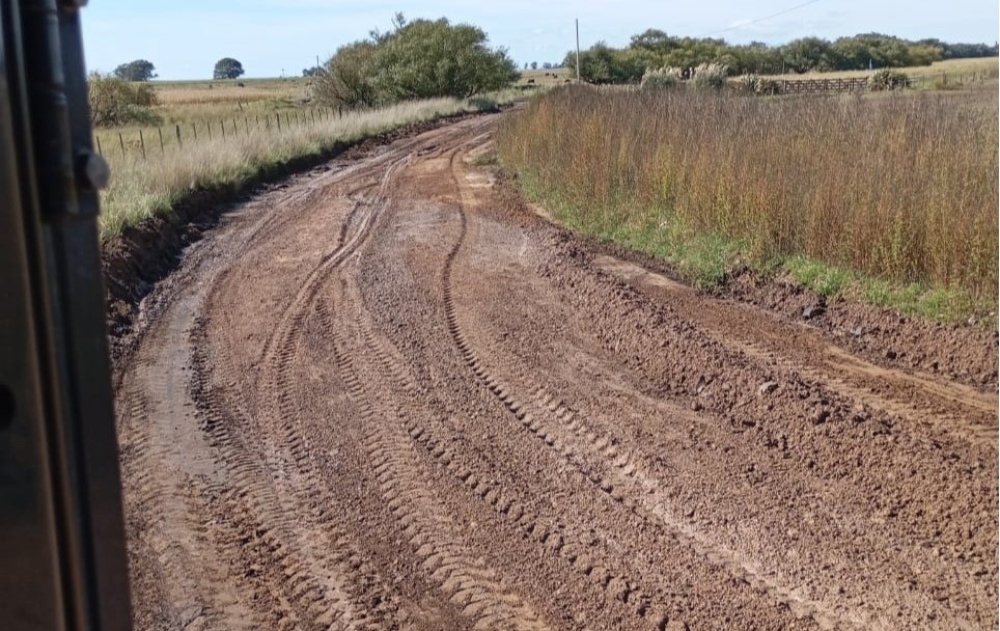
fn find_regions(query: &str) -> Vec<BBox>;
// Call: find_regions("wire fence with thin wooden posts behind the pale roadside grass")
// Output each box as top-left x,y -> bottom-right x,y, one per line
94,108 -> 344,160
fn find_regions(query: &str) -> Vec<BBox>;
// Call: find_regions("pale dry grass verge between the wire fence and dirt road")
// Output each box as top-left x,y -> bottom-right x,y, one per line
100,99 -> 477,240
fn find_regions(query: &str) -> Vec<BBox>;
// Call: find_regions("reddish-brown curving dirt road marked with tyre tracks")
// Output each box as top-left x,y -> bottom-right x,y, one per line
116,117 -> 998,631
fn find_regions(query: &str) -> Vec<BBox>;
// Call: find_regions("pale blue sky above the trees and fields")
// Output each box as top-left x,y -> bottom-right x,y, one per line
82,0 -> 1000,80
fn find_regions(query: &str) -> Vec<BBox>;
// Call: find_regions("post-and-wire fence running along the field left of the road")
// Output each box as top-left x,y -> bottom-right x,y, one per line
94,108 -> 346,160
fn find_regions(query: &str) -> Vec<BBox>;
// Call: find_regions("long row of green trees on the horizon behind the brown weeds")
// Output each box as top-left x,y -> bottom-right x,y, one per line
563,29 -> 998,83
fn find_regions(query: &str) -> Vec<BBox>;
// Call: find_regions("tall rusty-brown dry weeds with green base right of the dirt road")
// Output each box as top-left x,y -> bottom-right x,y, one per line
497,87 -> 998,300
